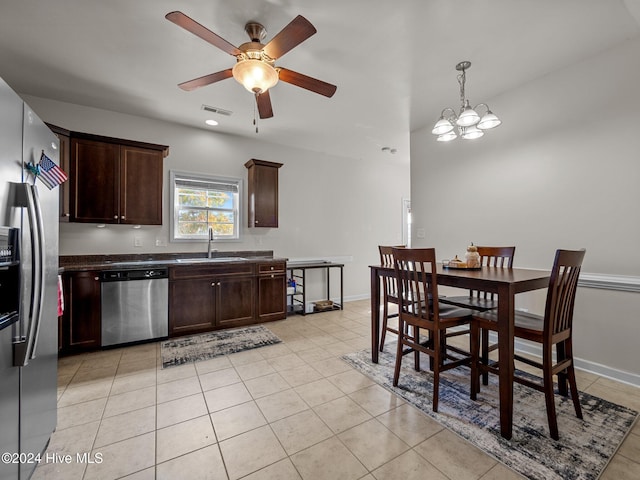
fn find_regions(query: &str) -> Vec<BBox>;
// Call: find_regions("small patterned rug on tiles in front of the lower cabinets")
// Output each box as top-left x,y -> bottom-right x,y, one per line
160,325 -> 282,368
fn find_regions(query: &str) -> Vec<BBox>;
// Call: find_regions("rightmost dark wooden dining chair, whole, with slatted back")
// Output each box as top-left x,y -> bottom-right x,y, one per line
471,249 -> 585,440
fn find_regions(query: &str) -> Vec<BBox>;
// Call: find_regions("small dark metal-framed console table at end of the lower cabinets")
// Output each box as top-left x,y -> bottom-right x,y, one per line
287,261 -> 344,315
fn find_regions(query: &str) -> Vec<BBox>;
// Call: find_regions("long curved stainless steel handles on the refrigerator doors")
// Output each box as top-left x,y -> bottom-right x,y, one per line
14,183 -> 45,366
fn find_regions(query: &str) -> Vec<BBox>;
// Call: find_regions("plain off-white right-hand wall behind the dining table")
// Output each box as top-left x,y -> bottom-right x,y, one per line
411,36 -> 640,384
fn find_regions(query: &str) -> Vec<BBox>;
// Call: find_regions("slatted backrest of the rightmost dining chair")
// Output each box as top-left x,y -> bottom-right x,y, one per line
544,249 -> 585,341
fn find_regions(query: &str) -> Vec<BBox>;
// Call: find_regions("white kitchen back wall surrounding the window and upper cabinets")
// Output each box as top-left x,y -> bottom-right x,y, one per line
24,96 -> 409,300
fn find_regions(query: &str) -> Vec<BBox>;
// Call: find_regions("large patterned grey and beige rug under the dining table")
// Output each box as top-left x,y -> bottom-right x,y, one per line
342,344 -> 638,480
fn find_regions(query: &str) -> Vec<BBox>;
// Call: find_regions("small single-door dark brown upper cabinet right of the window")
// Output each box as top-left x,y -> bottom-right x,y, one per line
244,159 -> 282,228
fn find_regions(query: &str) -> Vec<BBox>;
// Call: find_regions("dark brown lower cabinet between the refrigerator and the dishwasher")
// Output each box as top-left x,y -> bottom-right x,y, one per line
60,271 -> 101,354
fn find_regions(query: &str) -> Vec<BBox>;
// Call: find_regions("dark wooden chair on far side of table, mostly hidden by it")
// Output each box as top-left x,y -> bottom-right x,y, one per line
440,246 -> 516,385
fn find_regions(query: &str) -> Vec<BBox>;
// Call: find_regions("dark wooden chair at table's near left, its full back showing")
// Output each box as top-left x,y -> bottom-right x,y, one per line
392,248 -> 473,412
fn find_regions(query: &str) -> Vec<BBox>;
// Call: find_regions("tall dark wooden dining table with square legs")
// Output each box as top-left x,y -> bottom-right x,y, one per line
369,263 -> 551,439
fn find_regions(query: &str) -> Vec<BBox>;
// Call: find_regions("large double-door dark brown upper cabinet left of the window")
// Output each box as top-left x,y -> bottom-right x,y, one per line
70,132 -> 169,225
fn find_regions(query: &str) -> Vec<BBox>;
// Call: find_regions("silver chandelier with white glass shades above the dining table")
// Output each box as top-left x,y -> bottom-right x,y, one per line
431,61 -> 502,142
